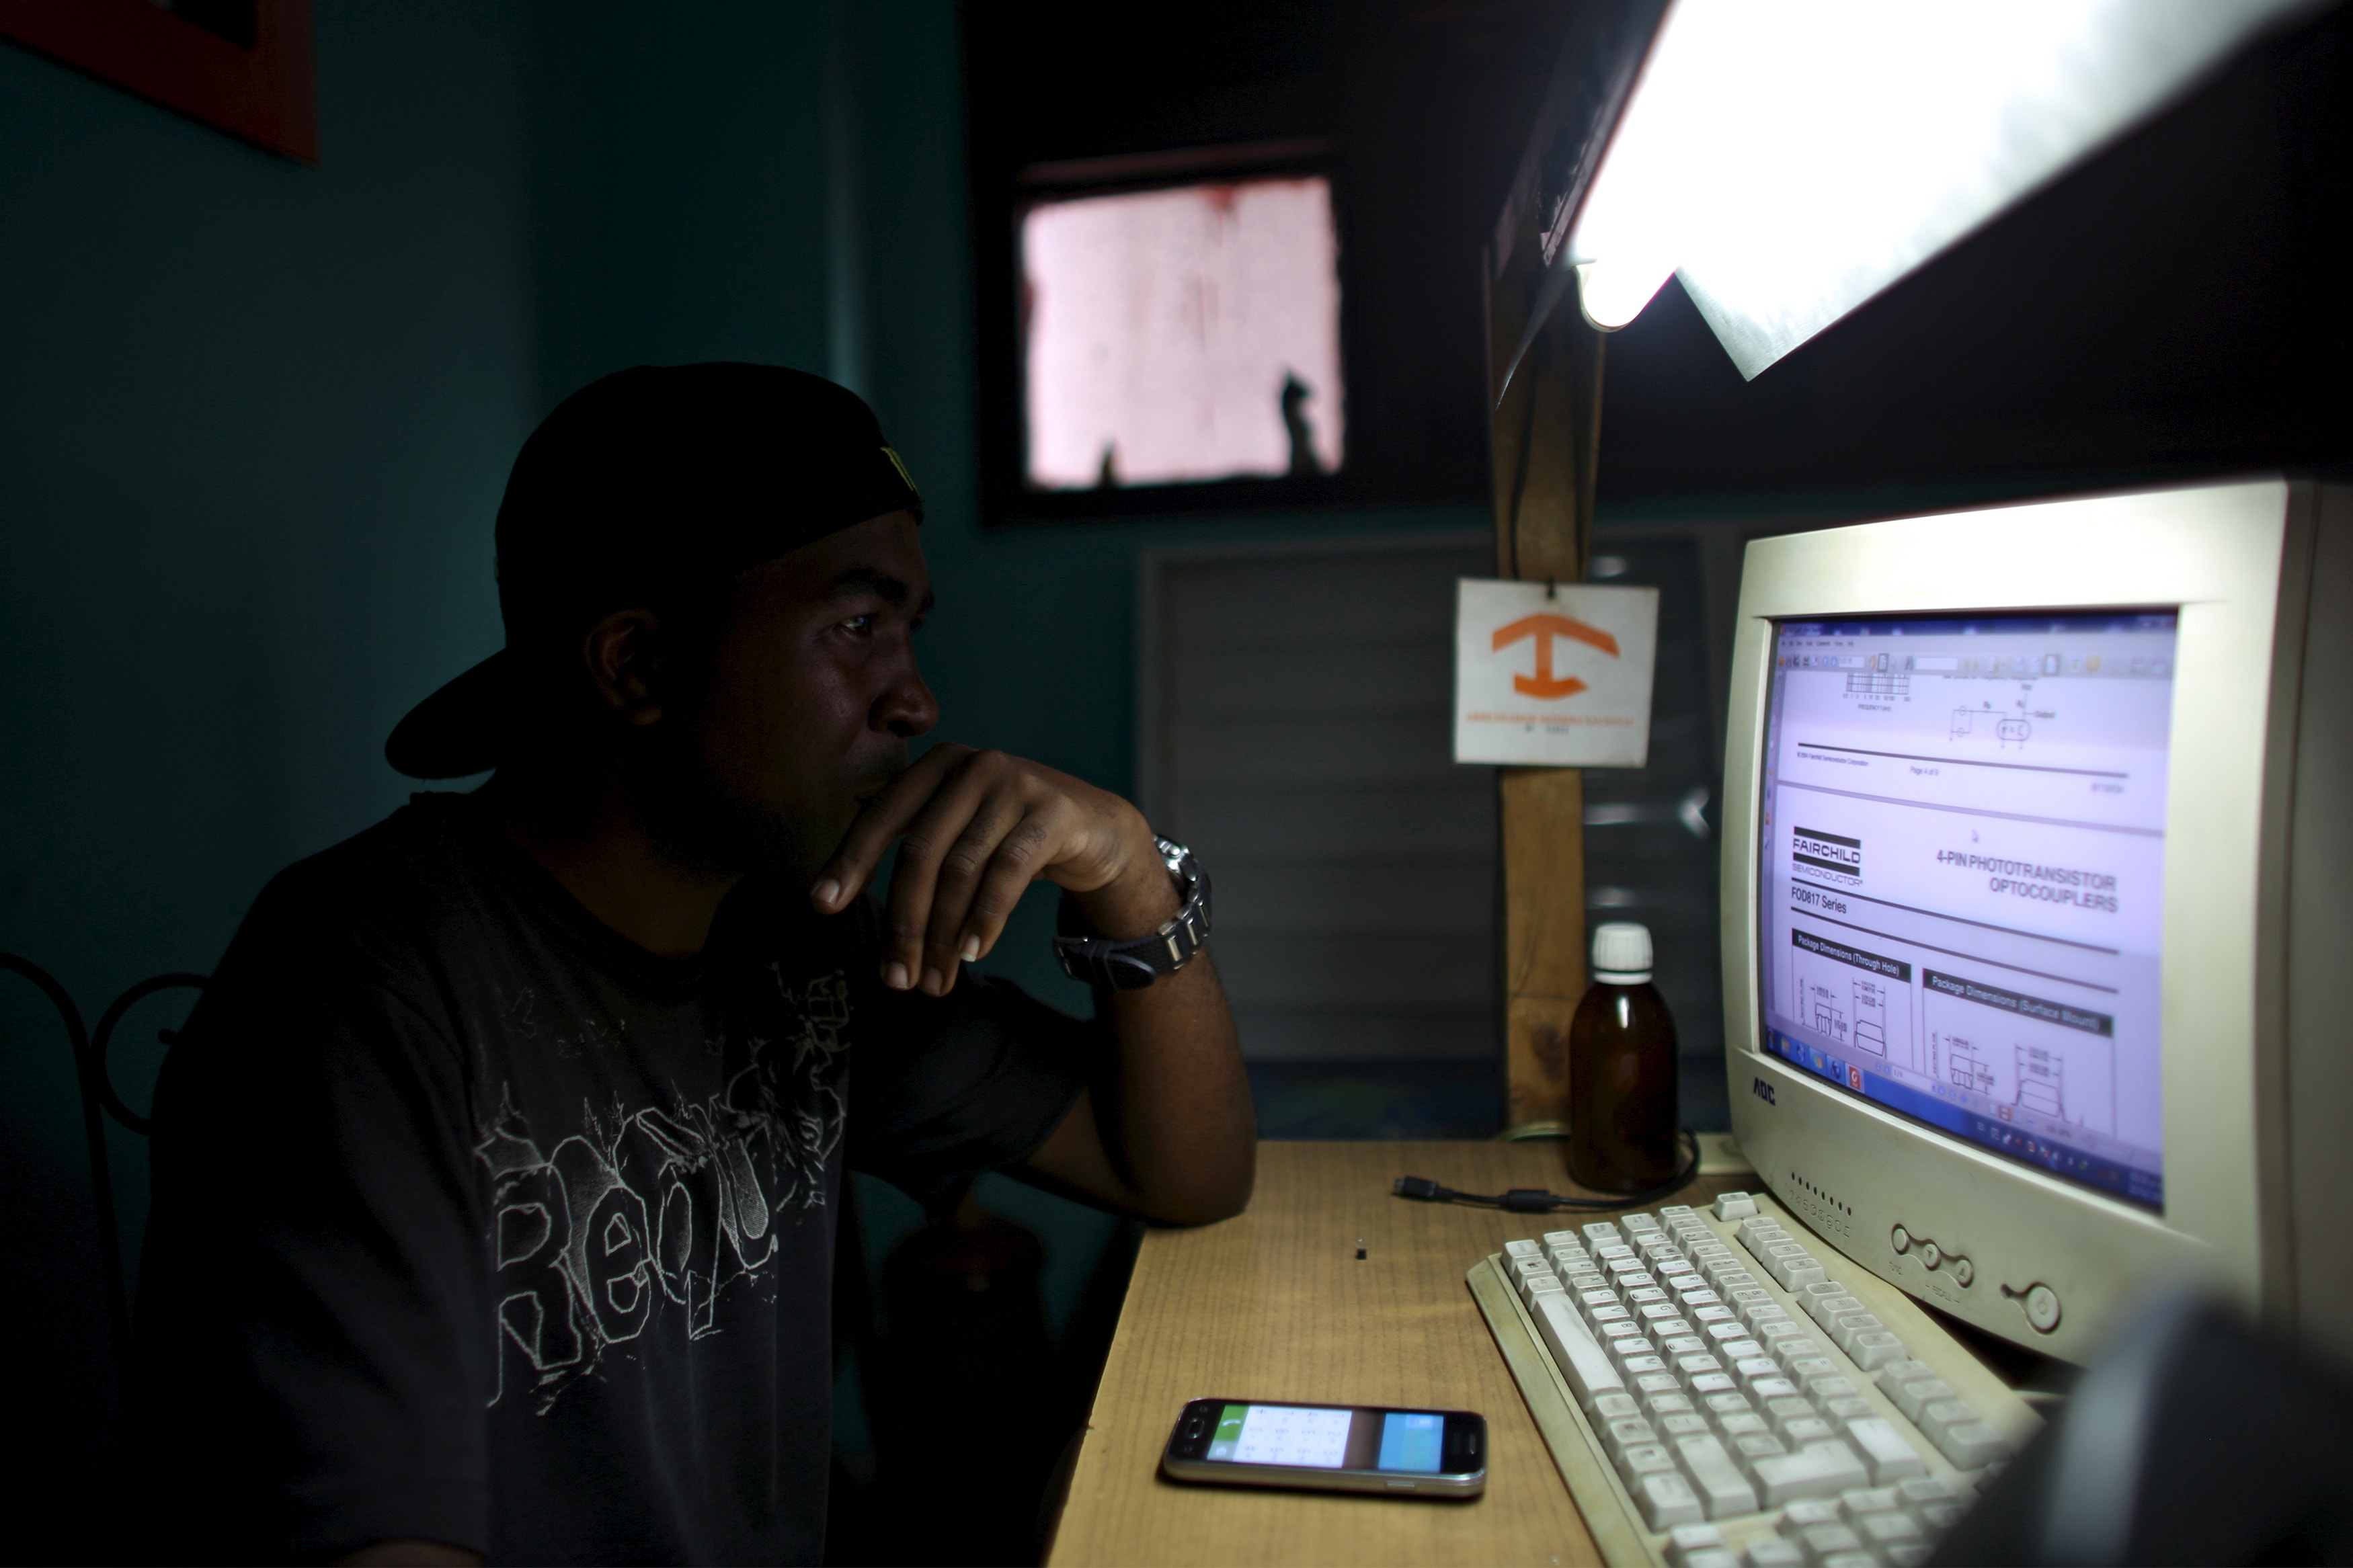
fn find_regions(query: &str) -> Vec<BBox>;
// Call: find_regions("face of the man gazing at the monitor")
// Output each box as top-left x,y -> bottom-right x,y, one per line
662,513 -> 939,877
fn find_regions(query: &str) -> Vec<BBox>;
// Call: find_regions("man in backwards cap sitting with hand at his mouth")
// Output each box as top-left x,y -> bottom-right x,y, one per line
132,364 -> 1254,1563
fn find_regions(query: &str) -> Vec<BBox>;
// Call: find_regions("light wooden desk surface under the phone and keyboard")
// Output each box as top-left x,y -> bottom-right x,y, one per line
1047,1143 -> 1746,1568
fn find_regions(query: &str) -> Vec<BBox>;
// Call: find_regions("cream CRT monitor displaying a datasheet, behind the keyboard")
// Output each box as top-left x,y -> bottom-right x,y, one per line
1722,480 -> 2353,1359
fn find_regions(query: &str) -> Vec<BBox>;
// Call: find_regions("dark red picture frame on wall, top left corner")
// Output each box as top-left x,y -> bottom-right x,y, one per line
0,0 -> 318,162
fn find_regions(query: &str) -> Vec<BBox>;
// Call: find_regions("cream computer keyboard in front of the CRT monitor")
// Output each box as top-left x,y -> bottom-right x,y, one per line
1471,1192 -> 2042,1568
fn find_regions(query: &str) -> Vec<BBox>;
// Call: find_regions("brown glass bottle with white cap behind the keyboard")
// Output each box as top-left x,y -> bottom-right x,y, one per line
1570,921 -> 1680,1192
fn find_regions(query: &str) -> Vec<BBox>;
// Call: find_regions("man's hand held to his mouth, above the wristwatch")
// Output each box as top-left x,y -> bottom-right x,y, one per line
809,743 -> 1179,997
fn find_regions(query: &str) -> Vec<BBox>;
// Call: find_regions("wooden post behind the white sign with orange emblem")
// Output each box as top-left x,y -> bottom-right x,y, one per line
1487,226 -> 1603,1138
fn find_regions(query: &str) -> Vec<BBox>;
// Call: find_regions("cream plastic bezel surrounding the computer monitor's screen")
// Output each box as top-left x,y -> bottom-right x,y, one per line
1720,480 -> 2311,1359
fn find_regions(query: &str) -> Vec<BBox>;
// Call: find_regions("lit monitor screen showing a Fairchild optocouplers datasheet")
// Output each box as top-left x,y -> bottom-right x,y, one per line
1758,611 -> 2177,1206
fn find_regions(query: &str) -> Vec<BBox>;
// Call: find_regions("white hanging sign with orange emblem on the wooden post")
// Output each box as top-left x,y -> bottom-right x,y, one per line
1454,578 -> 1659,769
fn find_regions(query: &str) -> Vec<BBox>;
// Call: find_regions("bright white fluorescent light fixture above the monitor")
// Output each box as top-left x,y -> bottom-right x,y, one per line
1565,0 -> 2315,378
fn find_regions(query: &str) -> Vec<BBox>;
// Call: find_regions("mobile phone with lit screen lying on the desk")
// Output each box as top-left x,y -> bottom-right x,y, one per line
1160,1399 -> 1487,1497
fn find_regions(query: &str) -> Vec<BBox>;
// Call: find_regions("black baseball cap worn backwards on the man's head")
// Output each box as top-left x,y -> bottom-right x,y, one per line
384,364 -> 922,778
